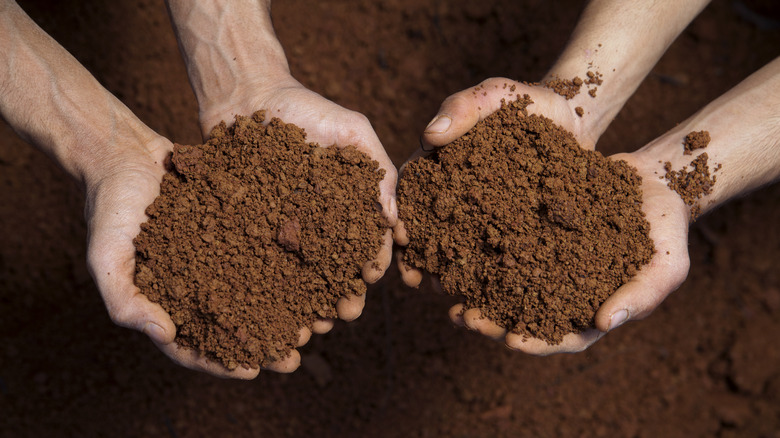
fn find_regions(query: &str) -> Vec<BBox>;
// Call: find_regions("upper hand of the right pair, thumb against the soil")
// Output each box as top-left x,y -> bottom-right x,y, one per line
394,78 -> 597,287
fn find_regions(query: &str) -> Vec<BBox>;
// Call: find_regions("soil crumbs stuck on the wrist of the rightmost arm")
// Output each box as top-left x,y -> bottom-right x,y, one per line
664,131 -> 721,221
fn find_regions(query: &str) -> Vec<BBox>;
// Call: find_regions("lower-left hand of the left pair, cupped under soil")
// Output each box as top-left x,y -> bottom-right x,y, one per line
85,135 -> 304,379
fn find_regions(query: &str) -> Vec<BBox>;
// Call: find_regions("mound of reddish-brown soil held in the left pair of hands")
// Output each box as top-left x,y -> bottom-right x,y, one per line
134,111 -> 387,369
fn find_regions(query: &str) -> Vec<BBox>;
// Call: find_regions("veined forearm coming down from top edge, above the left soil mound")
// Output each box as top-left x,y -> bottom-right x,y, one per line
167,0 -> 290,120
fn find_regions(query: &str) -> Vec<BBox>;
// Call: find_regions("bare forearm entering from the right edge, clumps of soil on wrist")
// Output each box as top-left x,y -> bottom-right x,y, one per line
638,58 -> 780,217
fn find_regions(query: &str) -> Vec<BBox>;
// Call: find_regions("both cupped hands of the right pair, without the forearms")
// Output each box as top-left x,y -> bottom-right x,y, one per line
394,78 -> 690,356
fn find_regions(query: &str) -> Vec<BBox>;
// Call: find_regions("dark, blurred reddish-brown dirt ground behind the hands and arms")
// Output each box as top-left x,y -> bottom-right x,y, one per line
0,0 -> 780,437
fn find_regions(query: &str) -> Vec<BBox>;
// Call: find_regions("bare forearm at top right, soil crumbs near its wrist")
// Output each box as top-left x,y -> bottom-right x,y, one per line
545,0 -> 710,138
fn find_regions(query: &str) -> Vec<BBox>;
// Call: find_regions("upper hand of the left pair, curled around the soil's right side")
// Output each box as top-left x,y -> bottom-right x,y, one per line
201,76 -> 398,326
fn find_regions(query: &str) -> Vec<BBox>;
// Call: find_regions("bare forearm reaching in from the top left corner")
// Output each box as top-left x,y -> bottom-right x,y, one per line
0,0 -> 154,183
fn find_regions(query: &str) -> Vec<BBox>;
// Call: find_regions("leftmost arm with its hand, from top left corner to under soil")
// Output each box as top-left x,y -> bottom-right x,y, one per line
0,0 -> 274,378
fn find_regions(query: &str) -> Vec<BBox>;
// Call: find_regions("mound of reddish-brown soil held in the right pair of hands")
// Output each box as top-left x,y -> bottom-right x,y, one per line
398,95 -> 655,344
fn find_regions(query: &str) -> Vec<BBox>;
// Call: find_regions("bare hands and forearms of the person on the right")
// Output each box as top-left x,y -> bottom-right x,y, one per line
395,0 -> 780,355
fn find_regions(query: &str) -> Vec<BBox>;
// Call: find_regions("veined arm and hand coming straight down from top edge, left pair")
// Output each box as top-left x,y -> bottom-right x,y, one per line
168,0 -> 397,322
